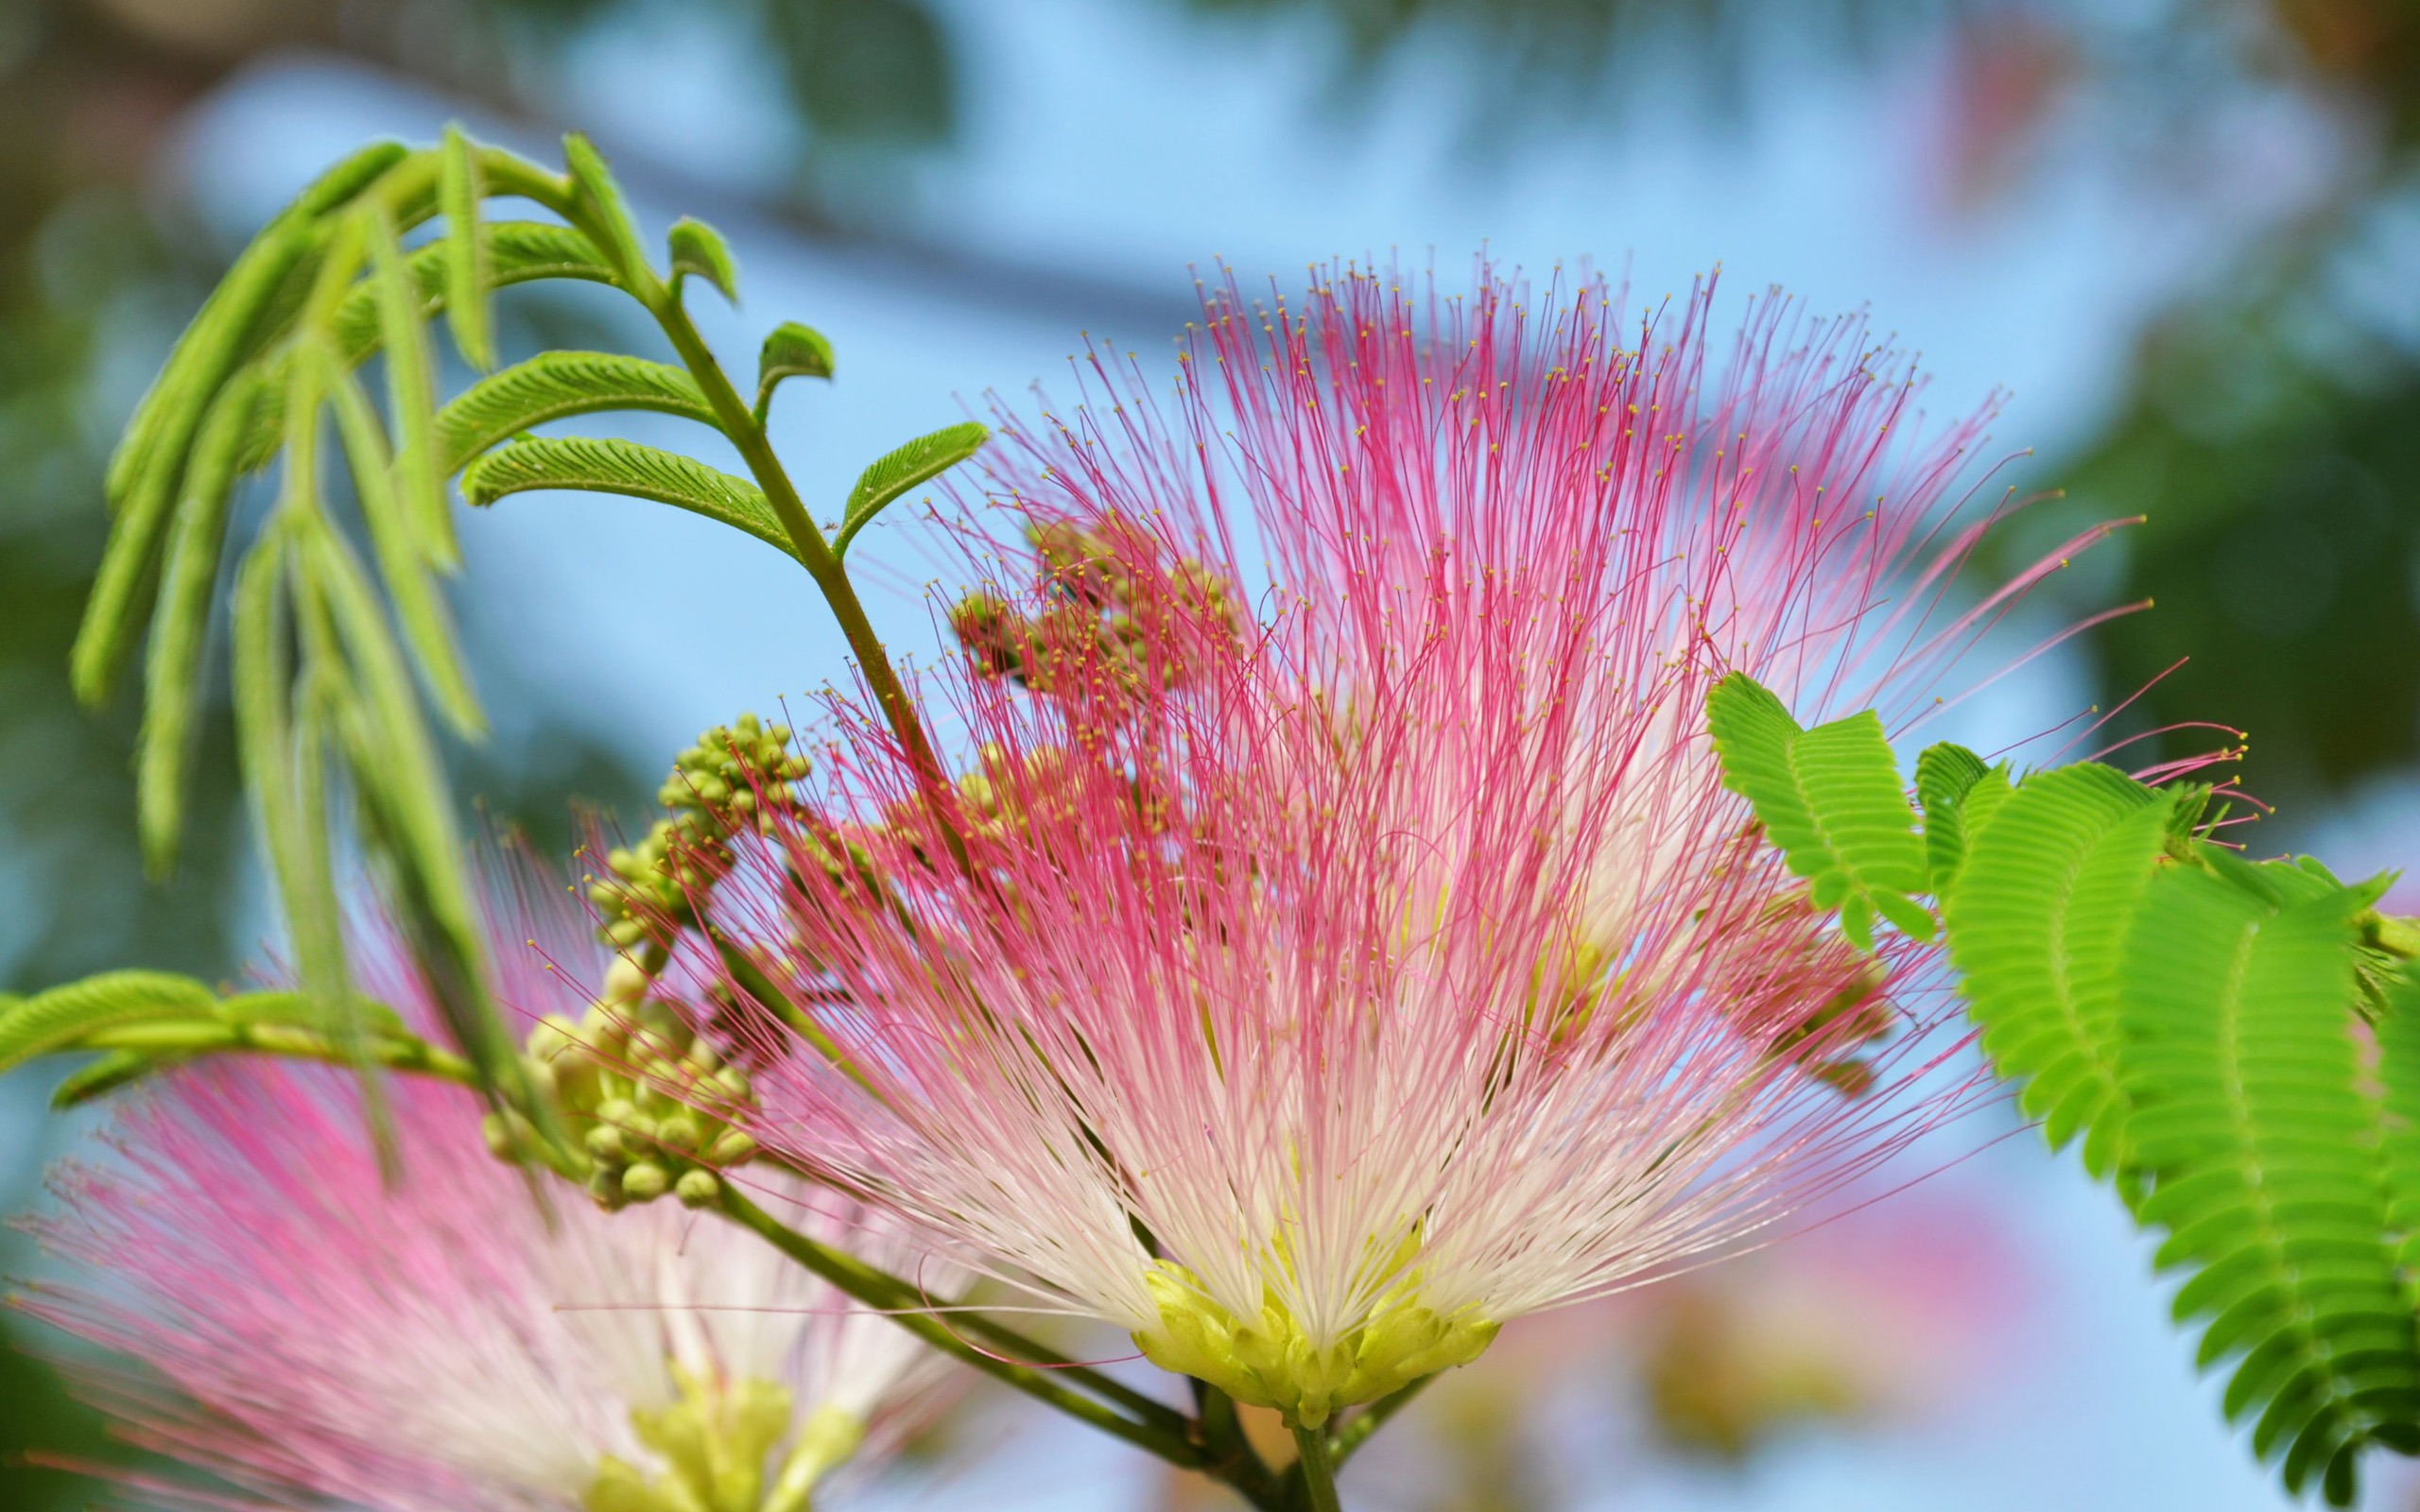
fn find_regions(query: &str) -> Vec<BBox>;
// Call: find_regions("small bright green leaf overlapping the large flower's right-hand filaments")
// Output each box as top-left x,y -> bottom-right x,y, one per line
1706,673 -> 1933,951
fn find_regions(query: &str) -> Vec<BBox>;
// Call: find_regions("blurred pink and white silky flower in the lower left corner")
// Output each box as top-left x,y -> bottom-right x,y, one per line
25,943 -> 946,1512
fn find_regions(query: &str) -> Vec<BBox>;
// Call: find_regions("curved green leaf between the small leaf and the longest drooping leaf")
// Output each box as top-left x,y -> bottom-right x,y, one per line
1944,765 -> 2169,1176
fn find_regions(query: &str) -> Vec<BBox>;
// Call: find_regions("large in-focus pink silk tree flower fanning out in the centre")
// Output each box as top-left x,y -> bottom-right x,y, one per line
709,262 -> 2071,1427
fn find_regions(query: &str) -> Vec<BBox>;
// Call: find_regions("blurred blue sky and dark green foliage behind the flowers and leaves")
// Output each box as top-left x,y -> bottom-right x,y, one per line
0,0 -> 2420,1512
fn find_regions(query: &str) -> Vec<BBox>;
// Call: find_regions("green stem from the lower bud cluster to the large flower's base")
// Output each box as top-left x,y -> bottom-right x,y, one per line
717,1183 -> 1205,1470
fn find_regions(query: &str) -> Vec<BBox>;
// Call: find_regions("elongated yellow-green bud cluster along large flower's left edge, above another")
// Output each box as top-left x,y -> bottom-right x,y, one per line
588,713 -> 808,951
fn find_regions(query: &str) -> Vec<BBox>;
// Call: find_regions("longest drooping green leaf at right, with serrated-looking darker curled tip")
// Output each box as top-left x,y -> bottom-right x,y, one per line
2120,851 -> 2420,1504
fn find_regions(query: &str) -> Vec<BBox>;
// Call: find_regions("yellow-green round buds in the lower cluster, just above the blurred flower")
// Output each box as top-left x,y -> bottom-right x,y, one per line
487,960 -> 757,1210
